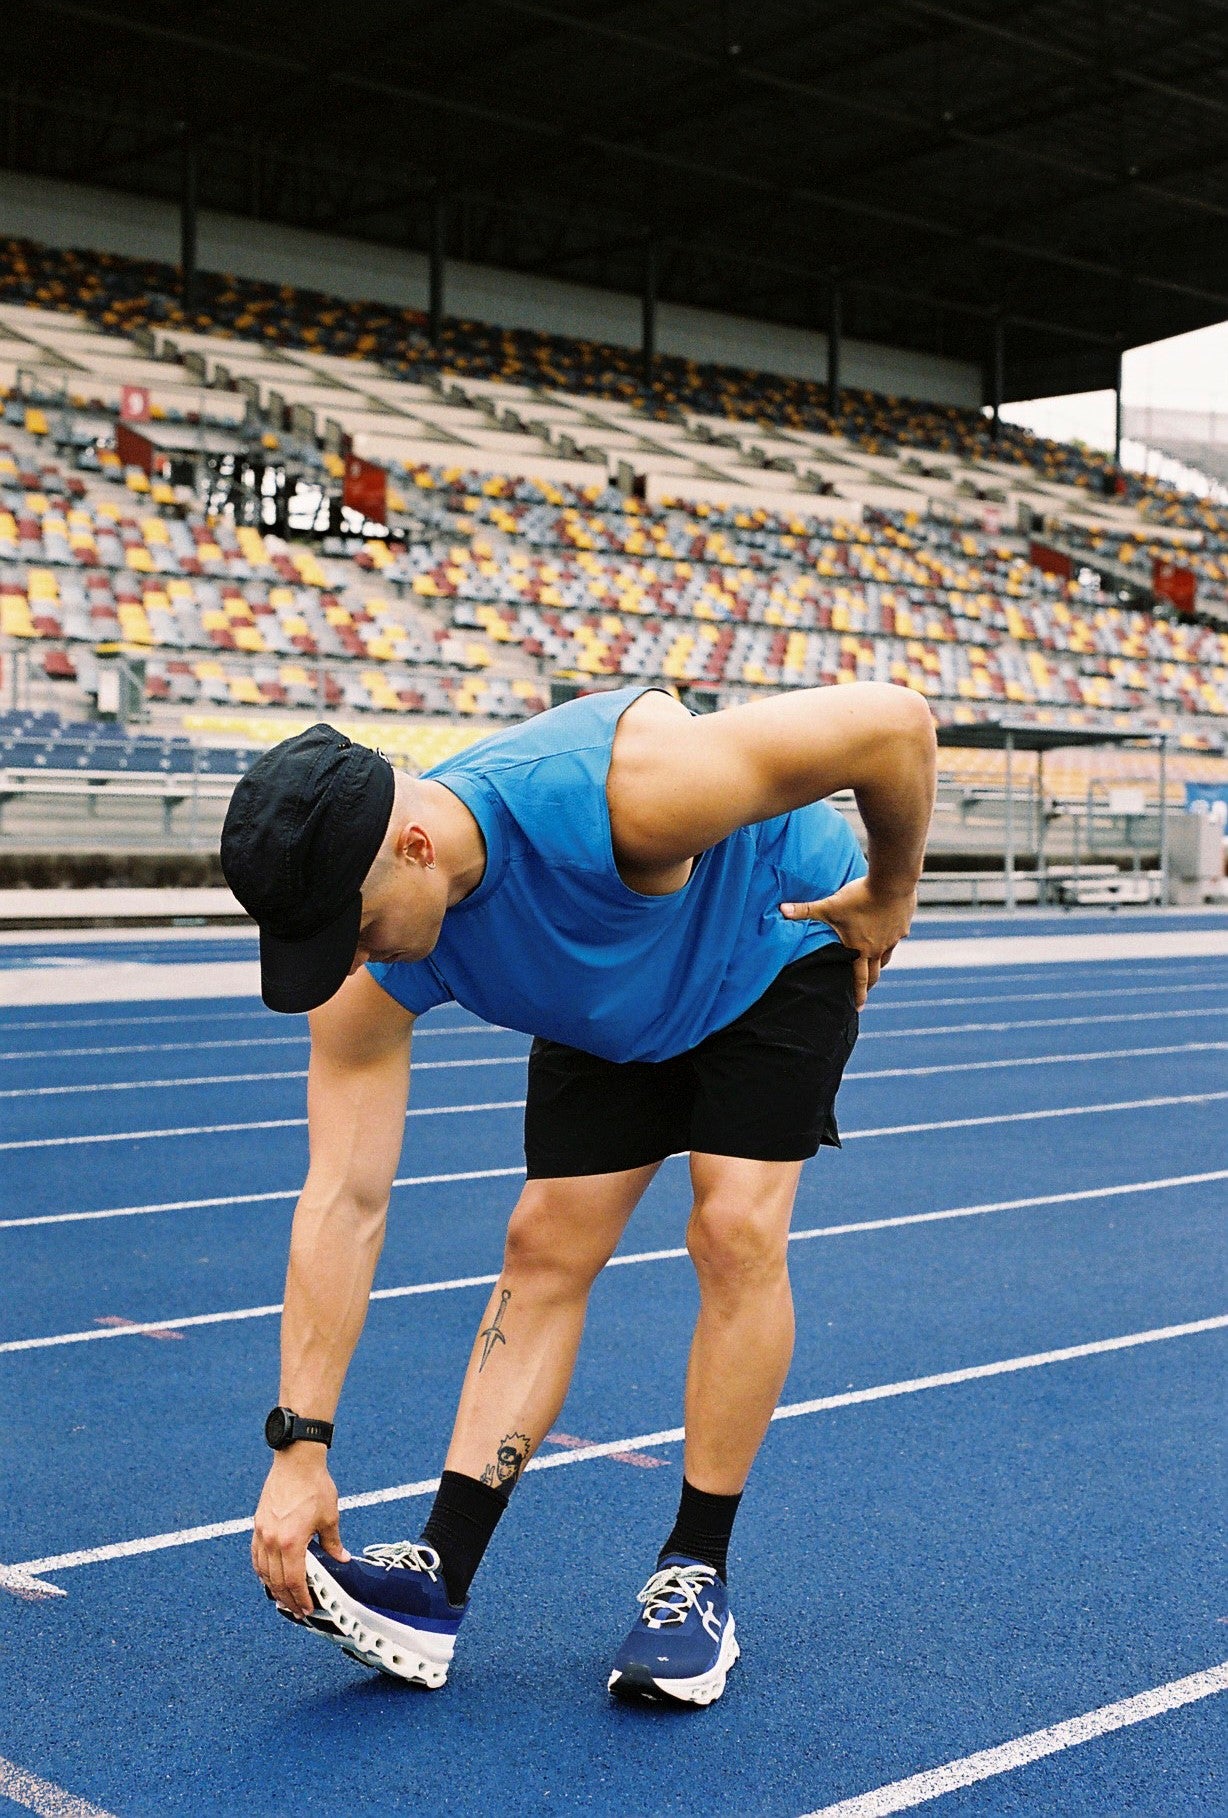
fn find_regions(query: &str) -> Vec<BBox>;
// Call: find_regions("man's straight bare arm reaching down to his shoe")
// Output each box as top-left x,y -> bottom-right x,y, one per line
251,973 -> 413,1616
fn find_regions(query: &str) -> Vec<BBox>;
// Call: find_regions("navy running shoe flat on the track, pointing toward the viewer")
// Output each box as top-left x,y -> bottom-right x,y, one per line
609,1554 -> 740,1703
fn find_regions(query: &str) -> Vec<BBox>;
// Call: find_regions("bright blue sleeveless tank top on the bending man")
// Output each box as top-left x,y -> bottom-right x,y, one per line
369,687 -> 866,1062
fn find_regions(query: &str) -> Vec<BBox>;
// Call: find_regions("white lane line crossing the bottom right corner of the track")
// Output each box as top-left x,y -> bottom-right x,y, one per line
808,1660 -> 1228,1818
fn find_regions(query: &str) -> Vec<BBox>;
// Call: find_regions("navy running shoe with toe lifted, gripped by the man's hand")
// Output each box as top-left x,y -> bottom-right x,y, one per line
306,1540 -> 469,1691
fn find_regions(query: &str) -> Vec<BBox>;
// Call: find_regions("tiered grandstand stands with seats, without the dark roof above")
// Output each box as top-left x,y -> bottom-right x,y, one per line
0,242 -> 1228,900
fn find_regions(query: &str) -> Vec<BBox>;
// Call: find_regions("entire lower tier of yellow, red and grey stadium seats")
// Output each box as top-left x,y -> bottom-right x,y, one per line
0,414 -> 1228,738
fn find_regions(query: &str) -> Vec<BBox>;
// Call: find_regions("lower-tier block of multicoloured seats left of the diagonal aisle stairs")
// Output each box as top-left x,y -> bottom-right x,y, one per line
0,444 -> 548,718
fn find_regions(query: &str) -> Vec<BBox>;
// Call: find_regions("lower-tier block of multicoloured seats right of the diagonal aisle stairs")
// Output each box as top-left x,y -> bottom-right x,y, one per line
386,474 -> 1228,734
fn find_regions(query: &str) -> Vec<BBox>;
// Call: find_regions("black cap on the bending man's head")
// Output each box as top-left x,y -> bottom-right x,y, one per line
222,725 -> 397,1013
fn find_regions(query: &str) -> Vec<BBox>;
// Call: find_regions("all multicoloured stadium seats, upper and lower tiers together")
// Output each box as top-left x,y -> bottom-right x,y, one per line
0,242 -> 1228,759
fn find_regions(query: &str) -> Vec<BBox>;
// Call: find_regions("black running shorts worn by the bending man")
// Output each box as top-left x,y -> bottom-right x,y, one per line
524,942 -> 859,1180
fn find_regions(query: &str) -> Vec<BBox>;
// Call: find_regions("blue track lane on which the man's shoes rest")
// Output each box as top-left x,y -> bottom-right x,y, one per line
0,1340 -> 1223,1818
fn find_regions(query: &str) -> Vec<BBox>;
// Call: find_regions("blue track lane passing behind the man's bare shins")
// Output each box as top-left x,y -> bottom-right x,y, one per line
0,1182 -> 1224,1562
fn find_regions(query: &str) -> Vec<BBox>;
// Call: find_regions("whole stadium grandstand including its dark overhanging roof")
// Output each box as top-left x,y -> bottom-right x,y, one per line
0,4 -> 1228,909
